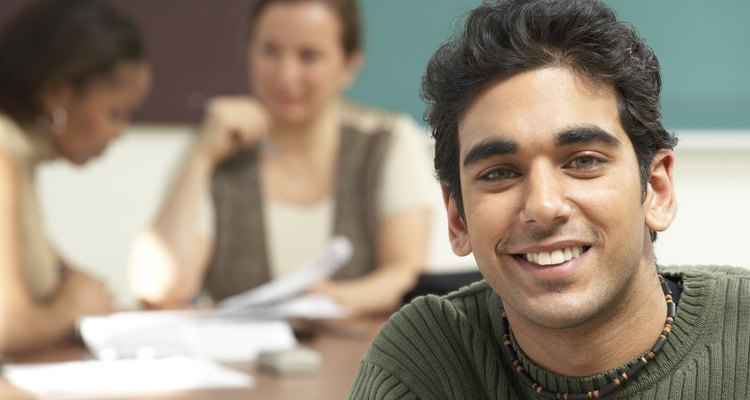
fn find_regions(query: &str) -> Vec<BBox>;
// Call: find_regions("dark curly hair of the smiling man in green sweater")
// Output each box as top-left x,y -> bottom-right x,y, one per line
422,0 -> 677,239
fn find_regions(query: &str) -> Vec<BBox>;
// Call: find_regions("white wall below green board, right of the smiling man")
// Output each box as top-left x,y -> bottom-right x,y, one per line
656,132 -> 750,268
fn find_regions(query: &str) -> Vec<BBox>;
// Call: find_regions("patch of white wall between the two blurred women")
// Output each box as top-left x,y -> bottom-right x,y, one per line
37,126 -> 191,307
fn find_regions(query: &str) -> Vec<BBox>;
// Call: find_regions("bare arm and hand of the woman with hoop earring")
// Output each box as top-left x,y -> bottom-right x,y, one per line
0,151 -> 112,353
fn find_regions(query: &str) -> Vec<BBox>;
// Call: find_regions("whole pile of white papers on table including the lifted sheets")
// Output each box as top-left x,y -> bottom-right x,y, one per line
78,236 -> 352,362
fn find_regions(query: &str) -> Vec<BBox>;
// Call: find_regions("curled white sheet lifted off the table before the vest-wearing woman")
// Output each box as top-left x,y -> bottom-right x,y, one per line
217,235 -> 353,308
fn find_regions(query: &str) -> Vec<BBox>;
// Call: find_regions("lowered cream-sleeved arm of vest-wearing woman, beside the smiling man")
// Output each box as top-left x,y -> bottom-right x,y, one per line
316,114 -> 437,316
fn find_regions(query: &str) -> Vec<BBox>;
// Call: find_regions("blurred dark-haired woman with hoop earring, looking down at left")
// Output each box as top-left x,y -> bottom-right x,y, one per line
0,0 -> 151,353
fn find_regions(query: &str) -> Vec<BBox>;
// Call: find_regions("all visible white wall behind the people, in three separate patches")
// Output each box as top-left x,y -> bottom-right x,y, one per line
38,126 -> 750,307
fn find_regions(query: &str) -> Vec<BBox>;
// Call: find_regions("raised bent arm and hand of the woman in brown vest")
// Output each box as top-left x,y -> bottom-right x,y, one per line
129,97 -> 270,308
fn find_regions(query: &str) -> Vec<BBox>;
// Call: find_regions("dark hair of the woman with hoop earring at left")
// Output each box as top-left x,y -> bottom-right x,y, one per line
0,0 -> 147,125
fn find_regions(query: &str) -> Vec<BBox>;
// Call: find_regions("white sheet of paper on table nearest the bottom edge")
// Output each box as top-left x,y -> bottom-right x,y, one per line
3,357 -> 253,399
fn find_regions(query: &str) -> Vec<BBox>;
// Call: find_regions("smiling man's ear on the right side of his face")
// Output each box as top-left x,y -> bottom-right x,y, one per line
643,149 -> 677,232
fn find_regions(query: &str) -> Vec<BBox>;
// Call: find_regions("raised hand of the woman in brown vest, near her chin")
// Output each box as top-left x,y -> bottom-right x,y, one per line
197,96 -> 271,166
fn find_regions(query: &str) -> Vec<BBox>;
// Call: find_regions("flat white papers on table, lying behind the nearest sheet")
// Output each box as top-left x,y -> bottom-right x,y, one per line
79,311 -> 297,362
